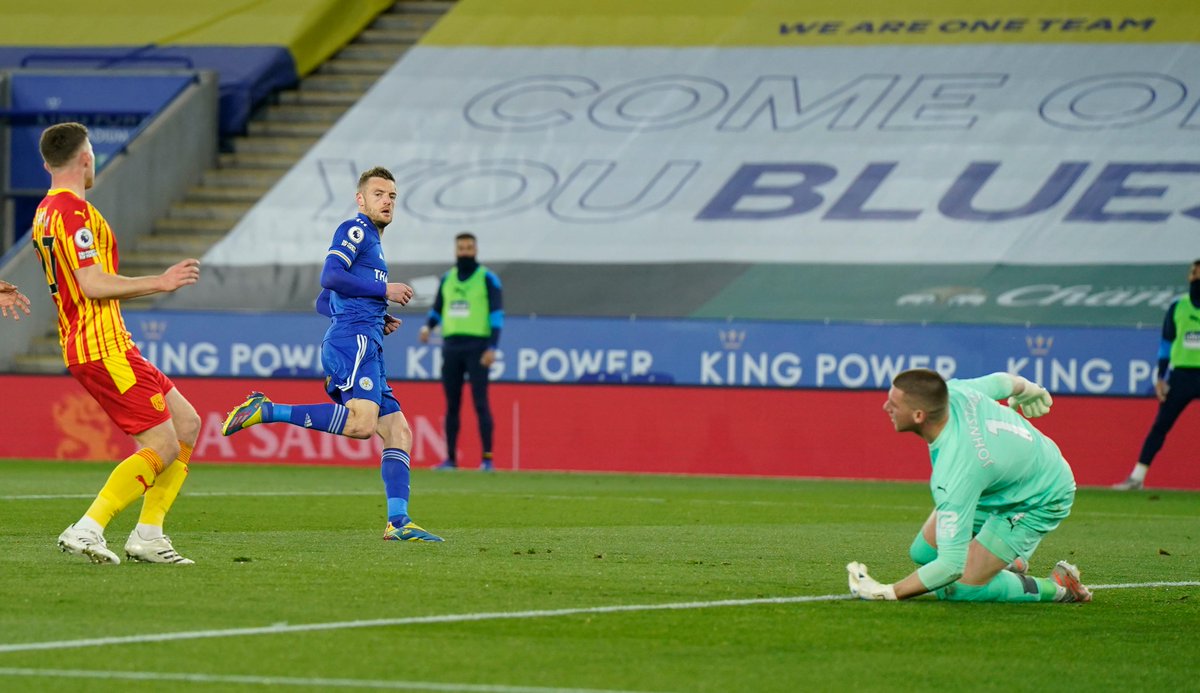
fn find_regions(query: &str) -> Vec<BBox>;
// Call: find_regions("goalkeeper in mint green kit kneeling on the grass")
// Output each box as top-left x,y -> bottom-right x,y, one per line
846,368 -> 1092,602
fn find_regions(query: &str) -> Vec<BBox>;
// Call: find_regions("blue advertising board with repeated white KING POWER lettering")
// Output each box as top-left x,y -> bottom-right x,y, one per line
126,311 -> 1158,396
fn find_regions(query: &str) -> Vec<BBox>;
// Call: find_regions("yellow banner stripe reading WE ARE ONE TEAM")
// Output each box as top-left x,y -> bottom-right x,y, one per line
422,0 -> 1200,47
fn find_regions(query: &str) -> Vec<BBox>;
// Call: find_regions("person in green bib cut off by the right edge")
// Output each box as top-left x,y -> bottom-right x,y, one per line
1112,260 -> 1200,490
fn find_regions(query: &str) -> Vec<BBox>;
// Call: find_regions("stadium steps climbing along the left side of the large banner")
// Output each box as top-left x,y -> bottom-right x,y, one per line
12,0 -> 455,373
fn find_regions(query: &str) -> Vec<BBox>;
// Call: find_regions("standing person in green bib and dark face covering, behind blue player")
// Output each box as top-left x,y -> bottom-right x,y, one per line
419,233 -> 504,471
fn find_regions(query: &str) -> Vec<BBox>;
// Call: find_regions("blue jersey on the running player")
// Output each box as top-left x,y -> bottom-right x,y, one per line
325,213 -> 388,342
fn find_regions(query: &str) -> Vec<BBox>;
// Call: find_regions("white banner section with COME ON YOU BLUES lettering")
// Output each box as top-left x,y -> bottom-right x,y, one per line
205,44 -> 1200,266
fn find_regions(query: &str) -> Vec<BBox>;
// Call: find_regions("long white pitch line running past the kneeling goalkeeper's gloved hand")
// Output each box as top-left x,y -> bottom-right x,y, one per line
0,580 -> 1200,653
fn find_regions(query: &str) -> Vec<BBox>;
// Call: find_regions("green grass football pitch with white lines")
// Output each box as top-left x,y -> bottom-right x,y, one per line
0,460 -> 1200,693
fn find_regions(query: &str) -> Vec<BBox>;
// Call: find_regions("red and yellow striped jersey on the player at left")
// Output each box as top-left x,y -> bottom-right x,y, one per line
31,188 -> 133,366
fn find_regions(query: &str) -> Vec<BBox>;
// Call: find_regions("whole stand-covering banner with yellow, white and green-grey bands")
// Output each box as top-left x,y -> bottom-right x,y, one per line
182,0 -> 1200,325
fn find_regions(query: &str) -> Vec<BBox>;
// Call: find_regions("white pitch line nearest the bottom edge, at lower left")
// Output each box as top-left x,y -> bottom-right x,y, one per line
0,667 -> 657,693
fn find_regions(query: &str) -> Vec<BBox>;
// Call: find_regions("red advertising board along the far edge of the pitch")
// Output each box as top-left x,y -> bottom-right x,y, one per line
0,375 -> 1200,489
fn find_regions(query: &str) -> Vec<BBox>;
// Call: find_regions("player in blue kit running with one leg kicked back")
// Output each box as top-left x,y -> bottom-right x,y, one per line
221,167 -> 442,542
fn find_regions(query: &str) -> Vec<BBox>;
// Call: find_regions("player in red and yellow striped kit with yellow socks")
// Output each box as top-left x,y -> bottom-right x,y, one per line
30,122 -> 200,565
